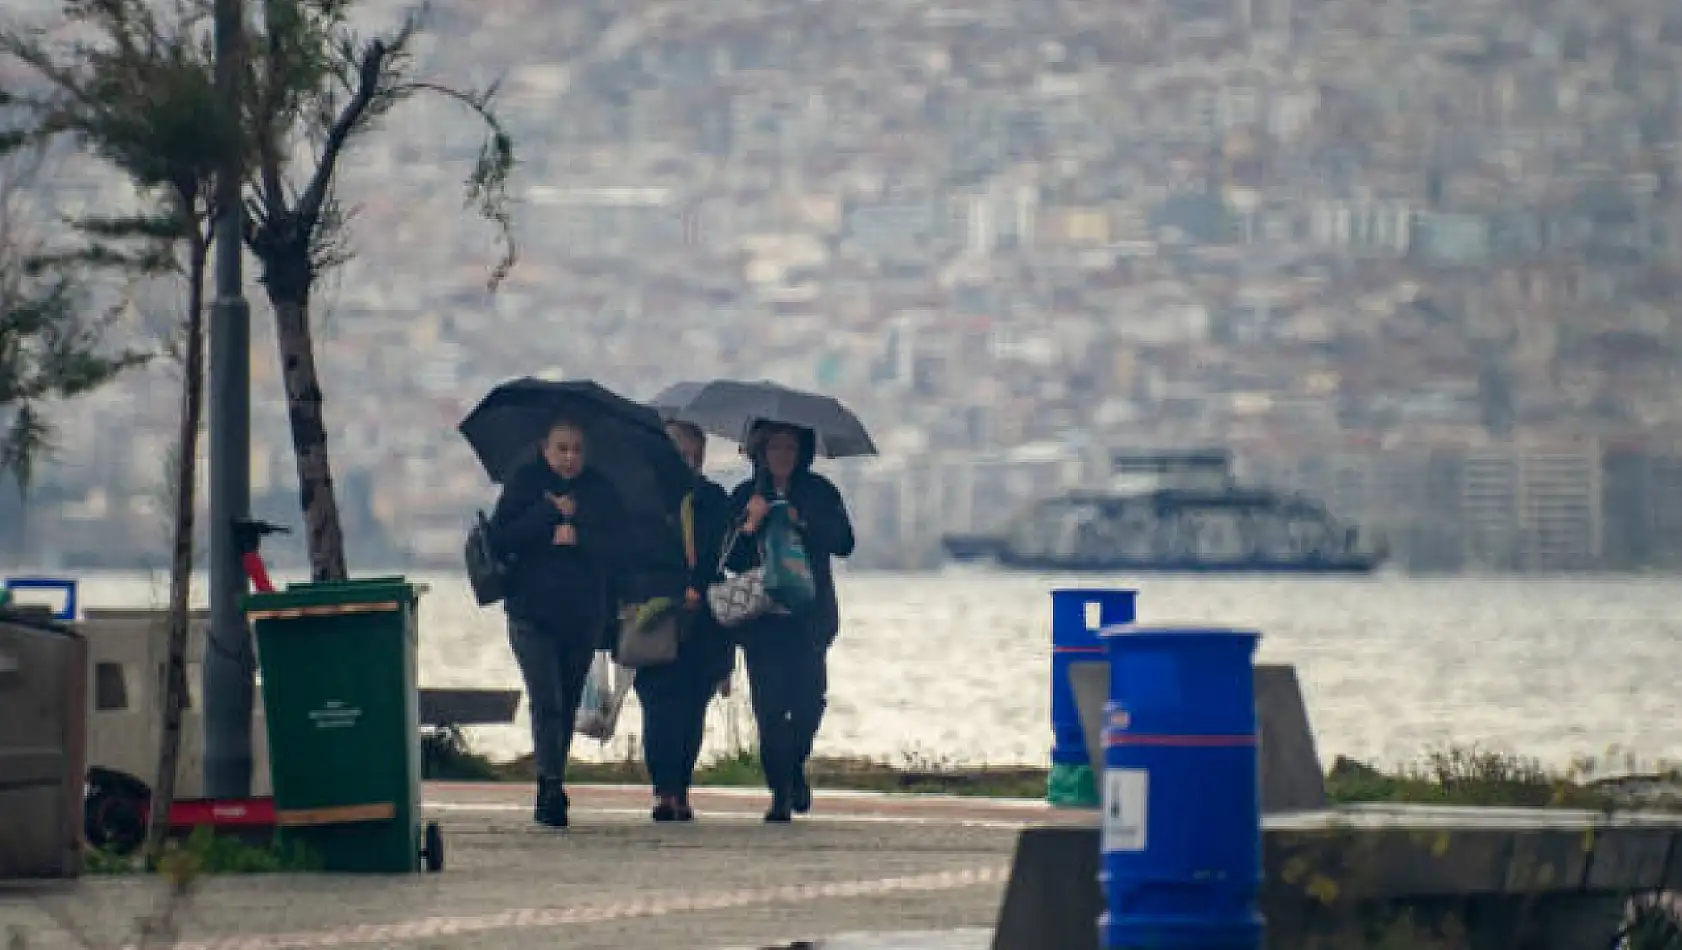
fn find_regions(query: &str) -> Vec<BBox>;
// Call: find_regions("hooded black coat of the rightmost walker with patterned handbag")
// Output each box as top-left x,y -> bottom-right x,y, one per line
730,459 -> 854,642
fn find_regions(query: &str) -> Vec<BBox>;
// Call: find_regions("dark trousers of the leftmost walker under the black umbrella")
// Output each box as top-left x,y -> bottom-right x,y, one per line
508,619 -> 600,782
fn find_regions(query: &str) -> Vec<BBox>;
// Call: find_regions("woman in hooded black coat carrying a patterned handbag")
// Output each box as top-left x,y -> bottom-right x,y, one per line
730,422 -> 853,822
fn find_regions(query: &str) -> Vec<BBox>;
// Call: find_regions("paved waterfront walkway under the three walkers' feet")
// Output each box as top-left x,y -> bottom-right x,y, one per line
0,784 -> 1092,950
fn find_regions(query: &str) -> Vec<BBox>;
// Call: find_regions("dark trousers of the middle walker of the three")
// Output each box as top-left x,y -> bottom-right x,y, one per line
632,652 -> 718,797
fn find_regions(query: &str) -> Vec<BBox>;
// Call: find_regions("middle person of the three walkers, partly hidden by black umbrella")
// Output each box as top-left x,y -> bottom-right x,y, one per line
632,422 -> 735,822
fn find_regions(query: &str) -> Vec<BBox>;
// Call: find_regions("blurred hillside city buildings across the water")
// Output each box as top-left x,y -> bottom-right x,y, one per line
13,0 -> 1682,570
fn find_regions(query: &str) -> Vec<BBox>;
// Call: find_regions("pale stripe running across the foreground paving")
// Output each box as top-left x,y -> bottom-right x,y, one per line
123,866 -> 1009,950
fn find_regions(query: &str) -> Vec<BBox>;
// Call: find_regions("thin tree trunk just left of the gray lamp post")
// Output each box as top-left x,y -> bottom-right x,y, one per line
145,232 -> 210,864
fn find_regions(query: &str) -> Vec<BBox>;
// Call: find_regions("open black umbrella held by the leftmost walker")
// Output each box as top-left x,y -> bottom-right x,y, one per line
459,377 -> 695,513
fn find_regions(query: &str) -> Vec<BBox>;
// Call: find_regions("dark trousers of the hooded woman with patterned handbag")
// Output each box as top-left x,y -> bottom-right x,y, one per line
742,617 -> 829,797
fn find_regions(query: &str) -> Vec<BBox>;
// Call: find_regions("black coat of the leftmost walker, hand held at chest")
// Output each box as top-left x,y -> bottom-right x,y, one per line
489,459 -> 626,634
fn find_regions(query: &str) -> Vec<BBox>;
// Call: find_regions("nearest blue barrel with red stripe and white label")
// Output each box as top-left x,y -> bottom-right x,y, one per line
1098,627 -> 1263,950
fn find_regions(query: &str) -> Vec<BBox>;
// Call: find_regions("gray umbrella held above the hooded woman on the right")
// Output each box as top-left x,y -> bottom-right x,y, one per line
649,380 -> 876,459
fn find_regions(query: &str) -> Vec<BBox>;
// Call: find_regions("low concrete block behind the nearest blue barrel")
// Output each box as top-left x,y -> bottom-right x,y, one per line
992,805 -> 1682,950
